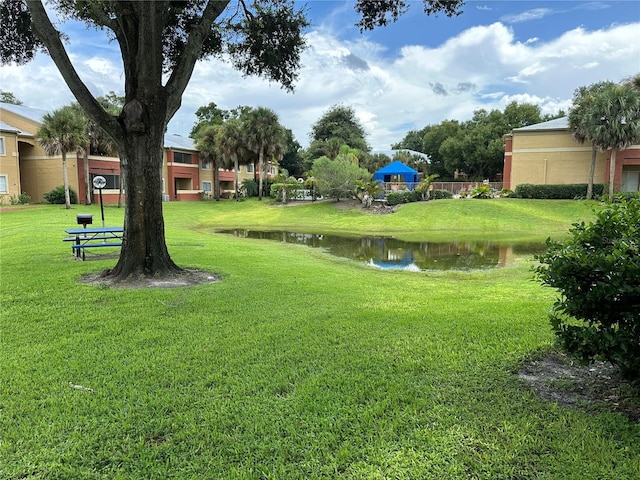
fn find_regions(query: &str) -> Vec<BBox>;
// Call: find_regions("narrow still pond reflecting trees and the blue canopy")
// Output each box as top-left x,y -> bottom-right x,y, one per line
217,229 -> 545,271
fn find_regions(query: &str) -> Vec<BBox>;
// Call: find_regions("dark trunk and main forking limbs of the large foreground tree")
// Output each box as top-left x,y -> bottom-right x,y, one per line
27,0 -> 228,281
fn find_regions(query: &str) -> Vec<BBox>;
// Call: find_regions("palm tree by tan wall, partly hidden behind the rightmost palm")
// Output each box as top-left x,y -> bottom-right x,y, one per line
569,82 -> 615,200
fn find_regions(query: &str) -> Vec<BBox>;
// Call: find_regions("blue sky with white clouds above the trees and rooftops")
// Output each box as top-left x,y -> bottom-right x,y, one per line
0,0 -> 640,151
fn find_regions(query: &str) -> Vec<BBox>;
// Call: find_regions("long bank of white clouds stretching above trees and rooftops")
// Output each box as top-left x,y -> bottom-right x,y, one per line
0,15 -> 640,149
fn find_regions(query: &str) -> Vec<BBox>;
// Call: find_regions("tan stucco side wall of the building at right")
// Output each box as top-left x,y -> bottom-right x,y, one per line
511,131 -> 607,189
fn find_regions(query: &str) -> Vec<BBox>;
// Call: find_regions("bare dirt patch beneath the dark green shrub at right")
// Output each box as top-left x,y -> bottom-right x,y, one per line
518,351 -> 640,422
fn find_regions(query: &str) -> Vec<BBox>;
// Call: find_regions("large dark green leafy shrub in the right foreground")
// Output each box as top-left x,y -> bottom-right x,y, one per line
535,199 -> 640,382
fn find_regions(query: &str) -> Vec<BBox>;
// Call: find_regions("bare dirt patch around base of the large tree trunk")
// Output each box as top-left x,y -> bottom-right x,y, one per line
80,269 -> 220,289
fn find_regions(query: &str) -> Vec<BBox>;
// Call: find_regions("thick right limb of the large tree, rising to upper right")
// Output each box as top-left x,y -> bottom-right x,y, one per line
165,0 -> 229,123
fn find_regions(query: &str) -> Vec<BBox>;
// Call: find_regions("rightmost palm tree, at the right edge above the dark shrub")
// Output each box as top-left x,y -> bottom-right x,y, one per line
588,83 -> 640,201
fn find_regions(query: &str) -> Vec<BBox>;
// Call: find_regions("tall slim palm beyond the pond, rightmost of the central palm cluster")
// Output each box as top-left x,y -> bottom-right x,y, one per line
245,107 -> 286,200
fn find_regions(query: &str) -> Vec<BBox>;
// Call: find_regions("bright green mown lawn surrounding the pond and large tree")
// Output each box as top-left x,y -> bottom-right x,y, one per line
0,200 -> 640,479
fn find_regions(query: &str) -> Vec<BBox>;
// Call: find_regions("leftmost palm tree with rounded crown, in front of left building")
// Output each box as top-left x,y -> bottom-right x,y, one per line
36,106 -> 87,209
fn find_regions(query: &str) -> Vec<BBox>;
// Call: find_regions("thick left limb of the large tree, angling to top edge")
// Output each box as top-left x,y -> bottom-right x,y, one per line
27,0 -> 121,139
